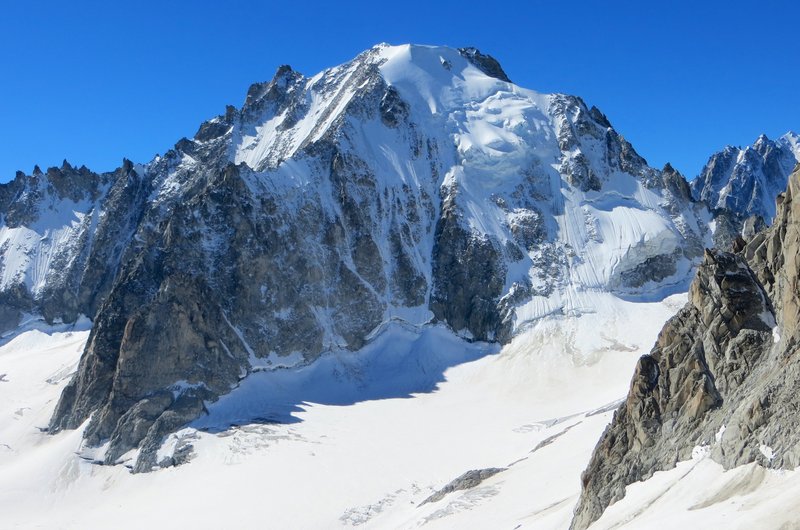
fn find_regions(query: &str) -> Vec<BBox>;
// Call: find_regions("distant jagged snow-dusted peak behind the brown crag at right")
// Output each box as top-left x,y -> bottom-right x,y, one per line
690,132 -> 800,249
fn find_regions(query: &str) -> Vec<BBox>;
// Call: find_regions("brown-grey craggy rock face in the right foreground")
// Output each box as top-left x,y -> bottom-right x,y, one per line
572,166 -> 800,529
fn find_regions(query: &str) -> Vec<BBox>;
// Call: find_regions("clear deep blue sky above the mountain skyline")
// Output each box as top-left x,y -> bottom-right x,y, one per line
0,0 -> 800,182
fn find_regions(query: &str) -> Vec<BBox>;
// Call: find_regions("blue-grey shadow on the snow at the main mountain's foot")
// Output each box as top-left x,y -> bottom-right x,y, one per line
190,324 -> 500,432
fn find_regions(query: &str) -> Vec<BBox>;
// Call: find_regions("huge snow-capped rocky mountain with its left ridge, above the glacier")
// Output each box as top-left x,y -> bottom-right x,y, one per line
0,45 -> 710,471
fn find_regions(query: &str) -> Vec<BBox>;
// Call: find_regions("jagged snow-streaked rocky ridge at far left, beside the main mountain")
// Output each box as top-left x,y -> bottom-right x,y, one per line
0,161 -> 134,332
